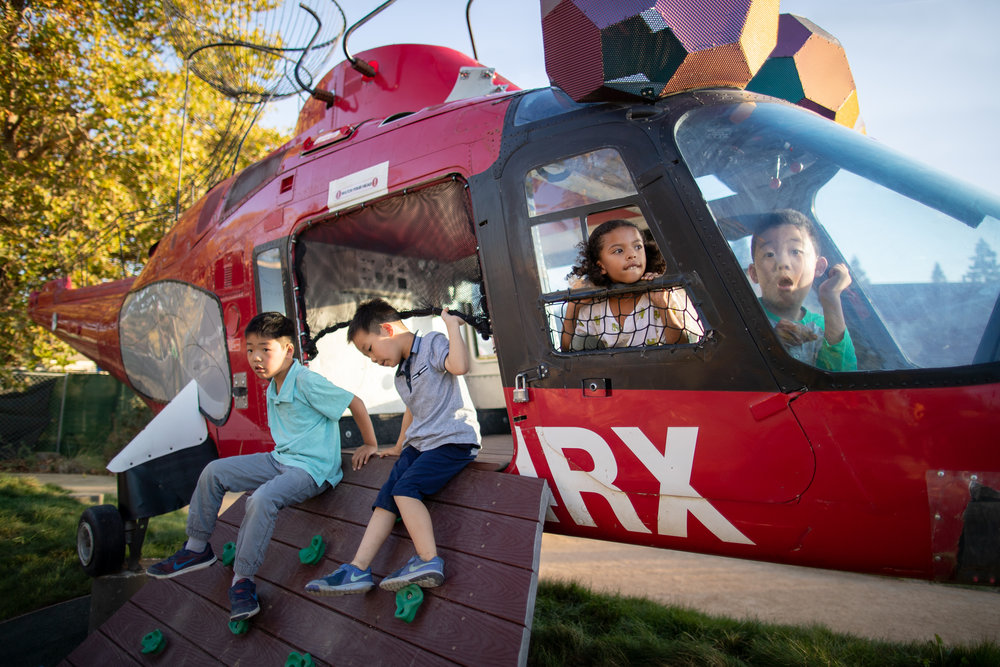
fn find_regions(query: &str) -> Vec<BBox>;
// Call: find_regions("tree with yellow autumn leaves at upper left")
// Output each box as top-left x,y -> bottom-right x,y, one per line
0,0 -> 284,378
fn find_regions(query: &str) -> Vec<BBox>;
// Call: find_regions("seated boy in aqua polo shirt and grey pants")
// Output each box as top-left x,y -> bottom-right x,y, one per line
146,313 -> 378,621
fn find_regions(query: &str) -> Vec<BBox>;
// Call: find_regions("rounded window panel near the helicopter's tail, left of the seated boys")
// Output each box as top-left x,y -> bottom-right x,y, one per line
119,281 -> 232,423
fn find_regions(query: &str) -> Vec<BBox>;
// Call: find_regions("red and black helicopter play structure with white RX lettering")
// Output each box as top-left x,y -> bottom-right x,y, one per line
32,1 -> 1000,584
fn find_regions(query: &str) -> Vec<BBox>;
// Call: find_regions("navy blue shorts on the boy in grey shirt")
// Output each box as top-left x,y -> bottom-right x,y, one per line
372,445 -> 479,516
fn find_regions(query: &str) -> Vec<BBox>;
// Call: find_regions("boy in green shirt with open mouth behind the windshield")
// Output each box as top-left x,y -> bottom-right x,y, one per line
748,209 -> 858,371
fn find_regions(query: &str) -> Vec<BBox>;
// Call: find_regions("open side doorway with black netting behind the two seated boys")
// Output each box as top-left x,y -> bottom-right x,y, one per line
293,178 -> 512,468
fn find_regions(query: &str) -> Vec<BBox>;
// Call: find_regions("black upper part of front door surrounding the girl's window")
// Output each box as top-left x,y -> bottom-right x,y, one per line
470,90 -> 777,391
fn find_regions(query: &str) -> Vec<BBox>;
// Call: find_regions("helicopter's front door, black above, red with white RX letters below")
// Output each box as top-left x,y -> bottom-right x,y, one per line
484,130 -> 815,545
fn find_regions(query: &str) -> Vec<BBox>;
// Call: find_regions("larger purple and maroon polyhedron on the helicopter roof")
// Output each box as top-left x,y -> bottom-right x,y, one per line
542,0 -> 778,102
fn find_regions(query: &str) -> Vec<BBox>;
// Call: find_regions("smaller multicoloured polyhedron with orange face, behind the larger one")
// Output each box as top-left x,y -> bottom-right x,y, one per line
747,14 -> 863,128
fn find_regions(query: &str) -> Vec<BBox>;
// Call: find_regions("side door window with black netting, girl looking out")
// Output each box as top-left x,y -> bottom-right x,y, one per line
525,148 -> 704,352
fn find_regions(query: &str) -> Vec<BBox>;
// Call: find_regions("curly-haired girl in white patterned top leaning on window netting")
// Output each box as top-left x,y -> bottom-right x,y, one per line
560,220 -> 704,351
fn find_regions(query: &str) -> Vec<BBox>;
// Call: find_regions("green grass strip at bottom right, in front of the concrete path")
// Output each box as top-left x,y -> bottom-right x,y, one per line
528,582 -> 1000,667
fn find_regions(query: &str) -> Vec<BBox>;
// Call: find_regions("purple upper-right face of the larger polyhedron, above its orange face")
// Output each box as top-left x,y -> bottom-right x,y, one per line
656,0 -> 754,53
